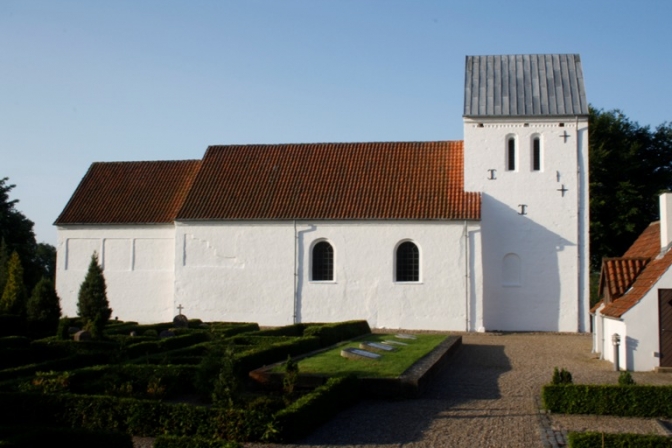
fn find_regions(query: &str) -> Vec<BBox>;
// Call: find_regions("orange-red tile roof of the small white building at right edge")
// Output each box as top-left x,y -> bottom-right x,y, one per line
601,222 -> 672,318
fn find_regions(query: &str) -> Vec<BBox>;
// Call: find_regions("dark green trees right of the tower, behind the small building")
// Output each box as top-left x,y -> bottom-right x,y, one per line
589,107 -> 672,270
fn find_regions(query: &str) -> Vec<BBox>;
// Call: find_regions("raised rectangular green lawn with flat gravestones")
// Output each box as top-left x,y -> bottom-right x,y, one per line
284,334 -> 447,378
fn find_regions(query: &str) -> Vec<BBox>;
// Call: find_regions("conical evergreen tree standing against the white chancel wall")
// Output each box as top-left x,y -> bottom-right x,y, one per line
77,252 -> 112,338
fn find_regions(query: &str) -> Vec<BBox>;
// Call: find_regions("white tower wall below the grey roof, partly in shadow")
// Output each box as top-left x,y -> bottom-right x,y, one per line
464,117 -> 589,332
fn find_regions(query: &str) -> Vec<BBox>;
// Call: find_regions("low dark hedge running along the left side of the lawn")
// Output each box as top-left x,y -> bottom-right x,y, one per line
234,337 -> 320,376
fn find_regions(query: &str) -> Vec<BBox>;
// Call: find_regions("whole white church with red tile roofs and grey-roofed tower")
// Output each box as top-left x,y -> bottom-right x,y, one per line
55,54 -> 589,332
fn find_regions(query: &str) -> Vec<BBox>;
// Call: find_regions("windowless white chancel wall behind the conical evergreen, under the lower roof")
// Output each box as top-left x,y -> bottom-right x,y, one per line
56,225 -> 175,322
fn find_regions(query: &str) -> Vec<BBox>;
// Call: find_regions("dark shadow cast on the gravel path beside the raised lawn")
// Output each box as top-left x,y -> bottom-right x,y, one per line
297,344 -> 511,446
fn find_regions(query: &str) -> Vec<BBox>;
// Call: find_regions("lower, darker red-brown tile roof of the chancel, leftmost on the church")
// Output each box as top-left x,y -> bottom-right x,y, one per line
54,160 -> 201,225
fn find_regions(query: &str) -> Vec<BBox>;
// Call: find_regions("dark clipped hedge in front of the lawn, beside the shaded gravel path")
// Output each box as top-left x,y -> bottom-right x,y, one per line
274,376 -> 360,442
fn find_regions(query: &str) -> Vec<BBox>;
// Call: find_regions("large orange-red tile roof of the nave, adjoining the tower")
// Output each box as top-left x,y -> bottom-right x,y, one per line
177,141 -> 481,220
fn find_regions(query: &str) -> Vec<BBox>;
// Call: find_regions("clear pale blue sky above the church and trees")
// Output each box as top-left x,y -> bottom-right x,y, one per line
0,0 -> 672,244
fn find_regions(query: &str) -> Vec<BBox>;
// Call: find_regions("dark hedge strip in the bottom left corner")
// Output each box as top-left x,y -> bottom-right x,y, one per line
0,426 -> 133,448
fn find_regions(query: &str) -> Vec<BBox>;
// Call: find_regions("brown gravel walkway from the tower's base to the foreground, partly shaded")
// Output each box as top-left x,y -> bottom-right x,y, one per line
248,333 -> 672,448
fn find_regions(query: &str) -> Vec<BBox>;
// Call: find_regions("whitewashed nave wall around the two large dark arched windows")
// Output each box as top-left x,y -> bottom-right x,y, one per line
175,221 -> 483,330
